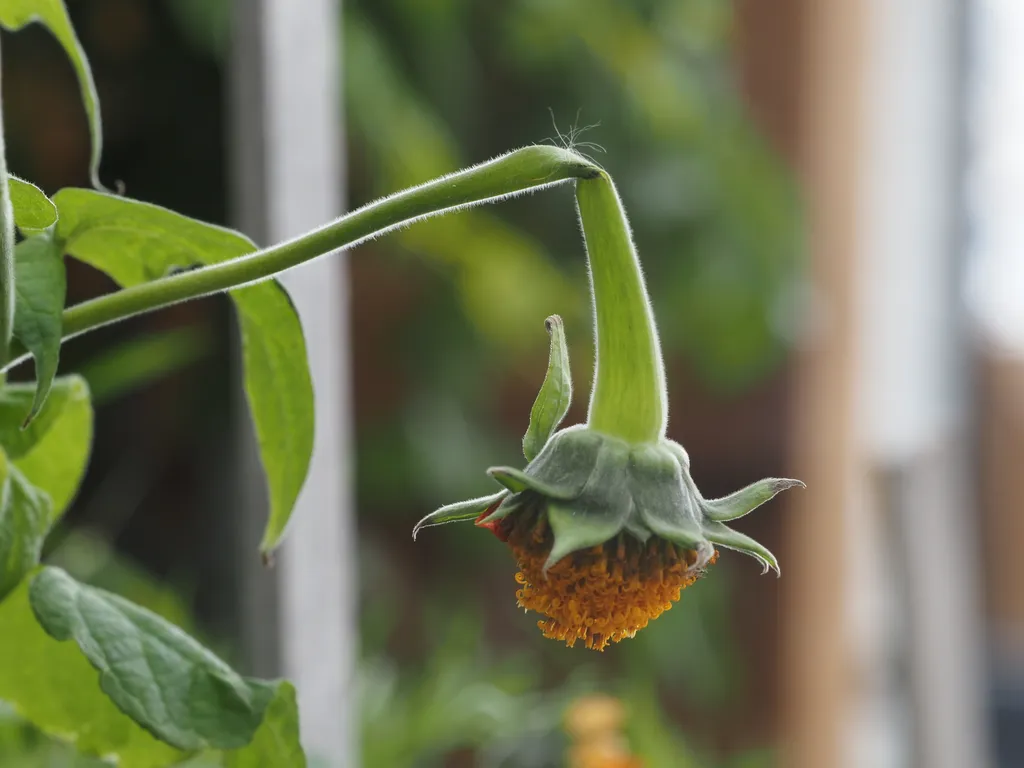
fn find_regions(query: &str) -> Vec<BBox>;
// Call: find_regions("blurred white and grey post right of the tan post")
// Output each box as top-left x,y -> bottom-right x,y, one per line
858,0 -> 988,768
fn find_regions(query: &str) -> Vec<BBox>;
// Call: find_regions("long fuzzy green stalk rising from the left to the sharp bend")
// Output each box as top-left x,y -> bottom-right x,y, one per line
3,145 -> 601,370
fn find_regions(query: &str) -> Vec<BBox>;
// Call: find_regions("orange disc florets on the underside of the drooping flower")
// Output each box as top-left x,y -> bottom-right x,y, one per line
508,514 -> 718,650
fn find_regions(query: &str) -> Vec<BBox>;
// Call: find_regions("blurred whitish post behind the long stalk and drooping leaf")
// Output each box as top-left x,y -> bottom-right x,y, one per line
231,0 -> 357,768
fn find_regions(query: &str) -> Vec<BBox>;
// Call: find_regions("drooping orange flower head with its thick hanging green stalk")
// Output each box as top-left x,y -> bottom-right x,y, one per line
413,172 -> 803,650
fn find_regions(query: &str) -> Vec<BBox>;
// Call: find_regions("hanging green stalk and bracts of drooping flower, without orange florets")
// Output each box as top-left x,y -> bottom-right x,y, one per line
413,172 -> 803,598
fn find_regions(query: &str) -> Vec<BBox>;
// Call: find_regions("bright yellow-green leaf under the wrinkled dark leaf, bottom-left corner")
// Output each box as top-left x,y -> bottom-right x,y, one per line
0,580 -> 183,768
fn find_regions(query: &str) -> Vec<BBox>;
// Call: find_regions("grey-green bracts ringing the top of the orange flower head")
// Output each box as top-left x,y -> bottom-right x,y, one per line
414,326 -> 803,572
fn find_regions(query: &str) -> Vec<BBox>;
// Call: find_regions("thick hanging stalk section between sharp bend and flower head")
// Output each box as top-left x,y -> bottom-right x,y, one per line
577,171 -> 669,442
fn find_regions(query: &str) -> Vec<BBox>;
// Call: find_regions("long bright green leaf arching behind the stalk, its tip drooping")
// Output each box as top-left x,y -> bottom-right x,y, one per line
53,189 -> 314,552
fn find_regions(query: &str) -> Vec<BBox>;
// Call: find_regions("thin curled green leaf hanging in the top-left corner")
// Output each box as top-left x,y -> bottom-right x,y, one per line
0,0 -> 103,187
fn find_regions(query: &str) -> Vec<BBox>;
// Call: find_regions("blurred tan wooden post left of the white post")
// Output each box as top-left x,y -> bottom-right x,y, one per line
780,0 -> 864,768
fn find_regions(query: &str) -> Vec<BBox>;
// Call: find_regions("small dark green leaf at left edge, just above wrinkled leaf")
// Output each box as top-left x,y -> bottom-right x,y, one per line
0,452 -> 50,600
